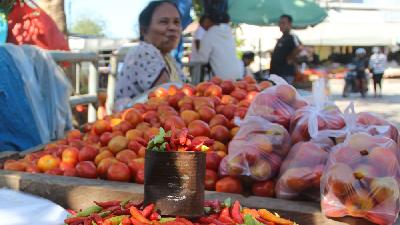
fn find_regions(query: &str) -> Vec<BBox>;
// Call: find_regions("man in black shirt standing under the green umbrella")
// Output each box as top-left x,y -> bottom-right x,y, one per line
270,15 -> 302,84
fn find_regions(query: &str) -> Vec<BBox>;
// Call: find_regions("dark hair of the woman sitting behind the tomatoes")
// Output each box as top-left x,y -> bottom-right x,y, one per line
139,0 -> 181,41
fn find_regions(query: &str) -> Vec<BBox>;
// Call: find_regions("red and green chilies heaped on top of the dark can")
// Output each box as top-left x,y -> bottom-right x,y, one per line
147,127 -> 214,152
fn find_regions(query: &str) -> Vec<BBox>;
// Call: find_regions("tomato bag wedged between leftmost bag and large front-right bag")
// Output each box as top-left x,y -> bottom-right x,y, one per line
275,138 -> 334,201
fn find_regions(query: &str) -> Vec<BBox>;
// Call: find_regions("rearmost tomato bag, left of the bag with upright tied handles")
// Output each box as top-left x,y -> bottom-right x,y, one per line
246,76 -> 308,129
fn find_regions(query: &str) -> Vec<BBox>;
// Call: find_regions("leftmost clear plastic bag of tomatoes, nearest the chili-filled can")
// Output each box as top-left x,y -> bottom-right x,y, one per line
219,116 -> 290,181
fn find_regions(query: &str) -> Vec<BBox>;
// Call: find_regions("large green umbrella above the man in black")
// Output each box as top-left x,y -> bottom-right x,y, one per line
228,0 -> 327,27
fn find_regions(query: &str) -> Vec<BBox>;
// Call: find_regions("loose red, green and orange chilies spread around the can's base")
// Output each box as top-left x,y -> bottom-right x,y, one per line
64,198 -> 295,225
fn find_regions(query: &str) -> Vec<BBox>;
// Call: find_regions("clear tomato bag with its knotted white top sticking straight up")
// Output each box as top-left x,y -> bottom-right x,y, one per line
289,79 -> 345,143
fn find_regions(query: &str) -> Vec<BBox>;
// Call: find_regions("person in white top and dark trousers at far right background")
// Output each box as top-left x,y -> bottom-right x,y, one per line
369,47 -> 387,97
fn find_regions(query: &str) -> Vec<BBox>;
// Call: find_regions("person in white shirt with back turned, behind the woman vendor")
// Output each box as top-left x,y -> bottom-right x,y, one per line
191,14 -> 243,80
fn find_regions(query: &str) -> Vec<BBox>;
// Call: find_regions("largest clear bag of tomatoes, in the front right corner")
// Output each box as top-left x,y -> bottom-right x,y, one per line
321,132 -> 400,224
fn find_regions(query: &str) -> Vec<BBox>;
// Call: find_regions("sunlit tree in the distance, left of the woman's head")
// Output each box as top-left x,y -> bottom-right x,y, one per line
71,18 -> 105,36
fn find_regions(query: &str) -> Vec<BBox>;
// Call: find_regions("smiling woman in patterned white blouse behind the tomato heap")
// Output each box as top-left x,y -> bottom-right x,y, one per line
115,0 -> 183,101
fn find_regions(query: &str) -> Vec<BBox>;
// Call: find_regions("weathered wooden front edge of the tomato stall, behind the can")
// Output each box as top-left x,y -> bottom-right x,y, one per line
0,170 -> 388,225
